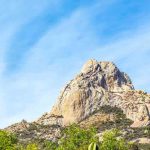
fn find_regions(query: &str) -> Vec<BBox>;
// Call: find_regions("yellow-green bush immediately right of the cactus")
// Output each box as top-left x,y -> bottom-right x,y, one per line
100,129 -> 129,150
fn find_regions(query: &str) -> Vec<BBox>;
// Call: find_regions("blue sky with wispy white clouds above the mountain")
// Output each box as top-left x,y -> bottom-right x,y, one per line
0,0 -> 150,128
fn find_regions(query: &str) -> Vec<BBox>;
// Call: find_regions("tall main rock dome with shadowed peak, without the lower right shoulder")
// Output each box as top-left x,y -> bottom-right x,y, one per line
50,59 -> 138,125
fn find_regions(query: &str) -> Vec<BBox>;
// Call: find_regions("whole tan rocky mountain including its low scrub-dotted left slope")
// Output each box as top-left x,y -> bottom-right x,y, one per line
6,60 -> 150,144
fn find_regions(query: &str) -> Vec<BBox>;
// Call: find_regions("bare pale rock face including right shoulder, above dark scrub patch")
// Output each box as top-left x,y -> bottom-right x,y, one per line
43,60 -> 150,127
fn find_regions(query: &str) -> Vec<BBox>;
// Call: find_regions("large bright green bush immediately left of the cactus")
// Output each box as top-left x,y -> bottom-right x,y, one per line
57,124 -> 98,150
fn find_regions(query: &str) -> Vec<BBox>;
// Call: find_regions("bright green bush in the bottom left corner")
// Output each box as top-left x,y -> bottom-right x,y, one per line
0,130 -> 17,150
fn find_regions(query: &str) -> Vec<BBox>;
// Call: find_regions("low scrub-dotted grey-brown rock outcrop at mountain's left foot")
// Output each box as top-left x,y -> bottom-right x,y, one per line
4,118 -> 62,143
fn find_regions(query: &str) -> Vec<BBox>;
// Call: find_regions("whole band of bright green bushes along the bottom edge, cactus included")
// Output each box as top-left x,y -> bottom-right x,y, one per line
0,124 -> 150,150
